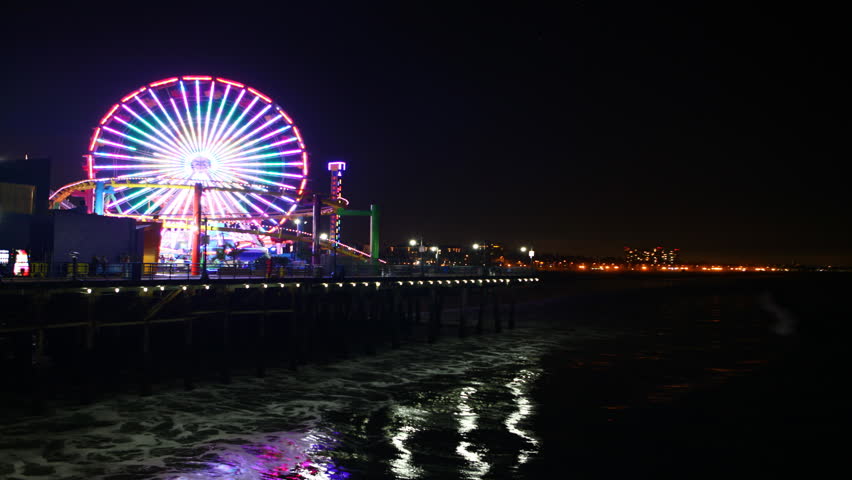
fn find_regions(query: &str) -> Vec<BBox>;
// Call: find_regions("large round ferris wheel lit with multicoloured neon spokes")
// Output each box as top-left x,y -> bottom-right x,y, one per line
87,75 -> 308,220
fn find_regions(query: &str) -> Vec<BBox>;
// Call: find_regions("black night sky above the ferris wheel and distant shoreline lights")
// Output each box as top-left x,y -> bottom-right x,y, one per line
0,2 -> 852,265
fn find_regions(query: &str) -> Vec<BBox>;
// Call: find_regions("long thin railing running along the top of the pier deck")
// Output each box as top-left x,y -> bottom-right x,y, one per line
0,262 -> 532,282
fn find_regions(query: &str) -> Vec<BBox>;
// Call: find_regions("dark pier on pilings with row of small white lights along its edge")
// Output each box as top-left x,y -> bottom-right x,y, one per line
0,276 -> 540,410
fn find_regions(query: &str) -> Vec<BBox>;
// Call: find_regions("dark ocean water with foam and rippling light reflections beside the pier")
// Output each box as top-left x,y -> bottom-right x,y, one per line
0,274 -> 844,480
